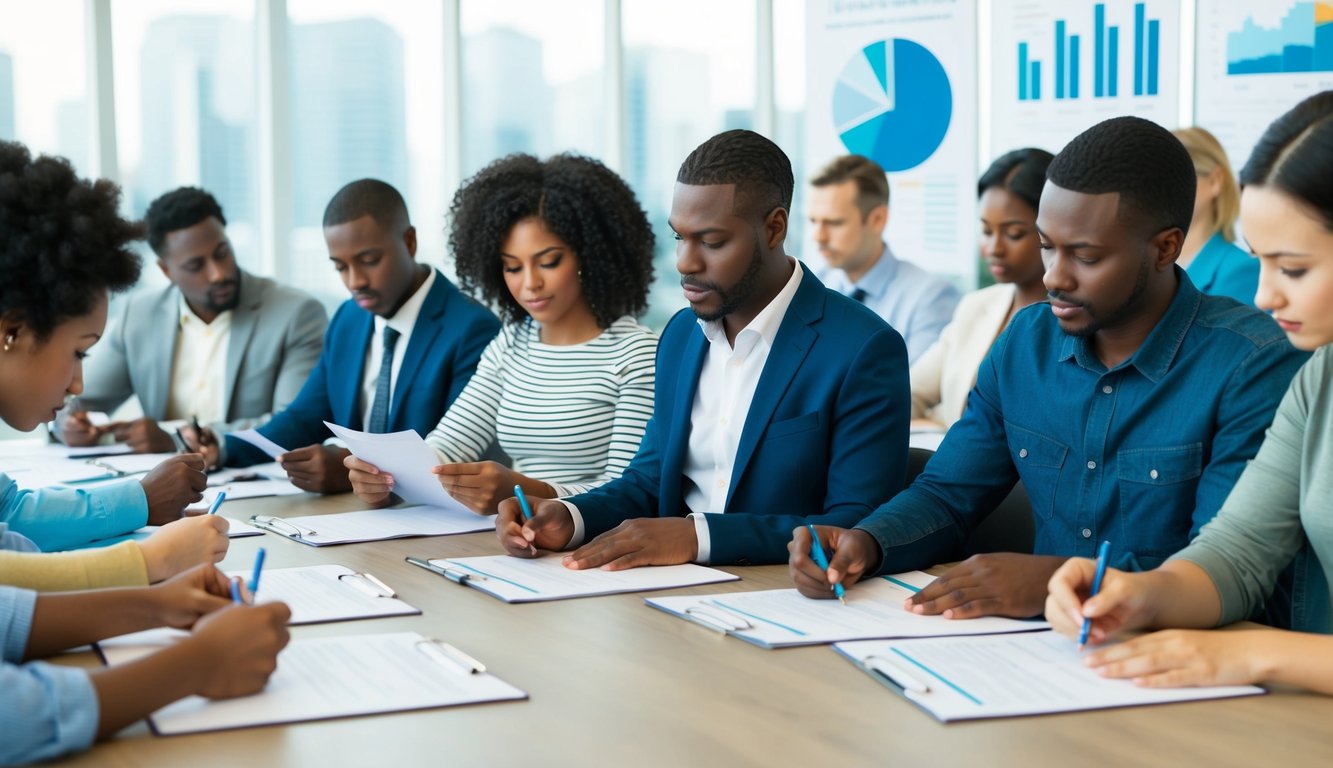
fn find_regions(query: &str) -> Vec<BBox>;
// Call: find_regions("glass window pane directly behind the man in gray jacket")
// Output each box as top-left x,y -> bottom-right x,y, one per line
111,0 -> 259,273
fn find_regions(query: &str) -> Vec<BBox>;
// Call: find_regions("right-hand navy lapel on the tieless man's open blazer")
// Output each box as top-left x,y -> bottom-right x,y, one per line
726,271 -> 824,508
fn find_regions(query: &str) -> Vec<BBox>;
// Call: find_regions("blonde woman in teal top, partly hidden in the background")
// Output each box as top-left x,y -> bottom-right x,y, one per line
1173,128 -> 1258,305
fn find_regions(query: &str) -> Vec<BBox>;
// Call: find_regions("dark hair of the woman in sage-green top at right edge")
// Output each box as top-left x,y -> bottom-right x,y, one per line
1241,91 -> 1333,231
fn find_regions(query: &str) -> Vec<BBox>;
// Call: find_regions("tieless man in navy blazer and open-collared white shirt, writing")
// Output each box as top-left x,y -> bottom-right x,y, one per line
497,131 -> 910,569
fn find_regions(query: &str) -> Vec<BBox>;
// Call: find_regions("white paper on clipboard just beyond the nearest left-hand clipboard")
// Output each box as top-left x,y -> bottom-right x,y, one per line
219,564 -> 420,624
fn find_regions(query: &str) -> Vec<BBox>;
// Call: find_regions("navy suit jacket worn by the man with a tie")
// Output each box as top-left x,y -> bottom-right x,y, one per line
225,271 -> 500,467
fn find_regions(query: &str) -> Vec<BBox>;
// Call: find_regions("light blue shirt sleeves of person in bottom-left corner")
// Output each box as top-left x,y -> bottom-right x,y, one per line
0,587 -> 100,765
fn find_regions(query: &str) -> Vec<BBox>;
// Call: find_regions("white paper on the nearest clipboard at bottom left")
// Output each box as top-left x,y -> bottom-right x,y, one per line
99,632 -> 527,735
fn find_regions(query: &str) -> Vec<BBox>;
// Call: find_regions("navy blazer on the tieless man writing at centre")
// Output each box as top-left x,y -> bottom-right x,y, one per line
569,269 -> 912,565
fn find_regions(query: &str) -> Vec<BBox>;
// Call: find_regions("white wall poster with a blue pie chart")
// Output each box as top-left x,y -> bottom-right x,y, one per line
796,0 -> 977,288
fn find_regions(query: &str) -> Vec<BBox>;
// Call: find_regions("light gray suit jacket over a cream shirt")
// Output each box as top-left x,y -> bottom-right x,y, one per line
79,271 -> 328,433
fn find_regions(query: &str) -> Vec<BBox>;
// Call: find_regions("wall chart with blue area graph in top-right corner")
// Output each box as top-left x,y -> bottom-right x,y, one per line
1194,0 -> 1333,171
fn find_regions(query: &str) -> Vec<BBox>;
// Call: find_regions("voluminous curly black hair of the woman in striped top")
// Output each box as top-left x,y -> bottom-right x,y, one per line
449,152 -> 655,328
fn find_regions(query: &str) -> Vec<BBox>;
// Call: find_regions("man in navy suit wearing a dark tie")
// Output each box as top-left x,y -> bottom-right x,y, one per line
201,179 -> 500,493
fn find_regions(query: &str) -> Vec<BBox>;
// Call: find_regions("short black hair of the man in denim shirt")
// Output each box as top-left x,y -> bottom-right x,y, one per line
1046,117 -> 1198,235
